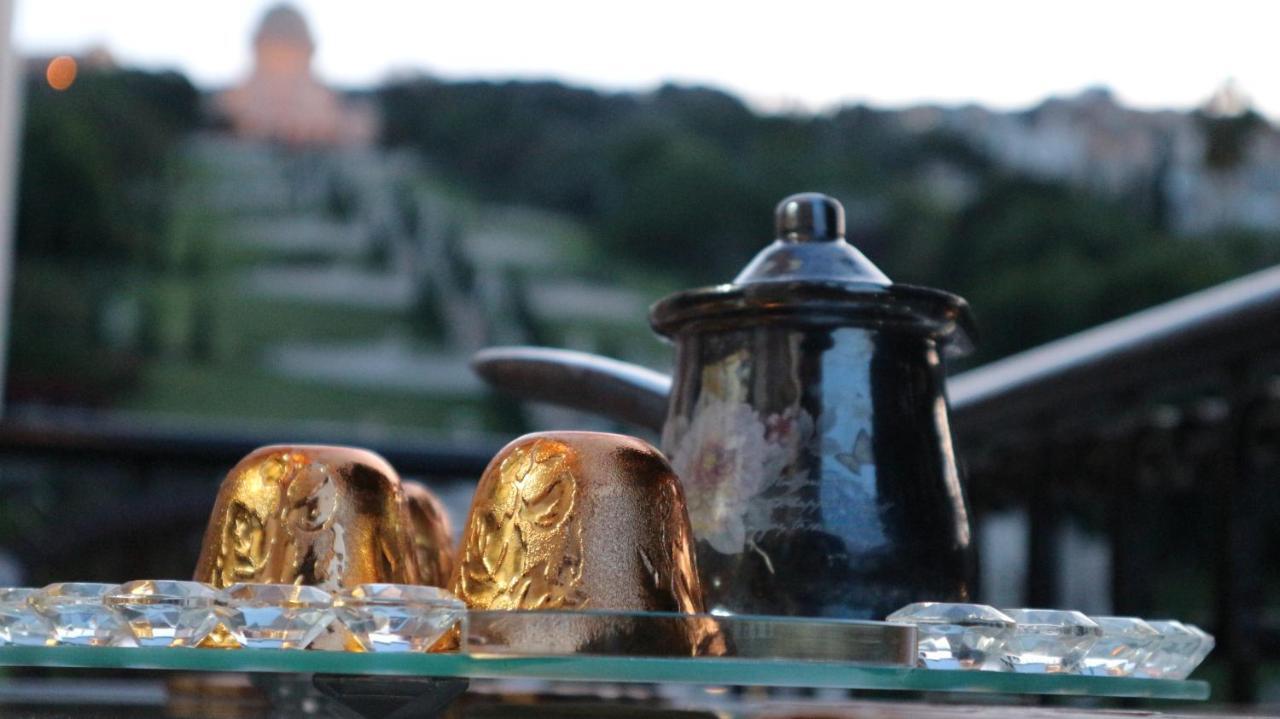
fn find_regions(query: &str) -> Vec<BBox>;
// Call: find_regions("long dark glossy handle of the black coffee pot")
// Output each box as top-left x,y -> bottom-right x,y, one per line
471,347 -> 671,432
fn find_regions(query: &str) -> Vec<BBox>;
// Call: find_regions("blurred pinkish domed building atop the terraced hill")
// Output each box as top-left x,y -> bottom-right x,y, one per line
218,4 -> 376,146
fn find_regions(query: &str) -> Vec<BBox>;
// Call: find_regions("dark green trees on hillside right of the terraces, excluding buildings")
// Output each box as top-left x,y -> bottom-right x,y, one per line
379,78 -> 1280,360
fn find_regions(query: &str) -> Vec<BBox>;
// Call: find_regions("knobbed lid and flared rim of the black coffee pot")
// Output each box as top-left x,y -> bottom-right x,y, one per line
649,192 -> 974,354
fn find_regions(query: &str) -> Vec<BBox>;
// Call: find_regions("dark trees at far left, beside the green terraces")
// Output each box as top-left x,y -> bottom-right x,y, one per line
6,68 -> 202,404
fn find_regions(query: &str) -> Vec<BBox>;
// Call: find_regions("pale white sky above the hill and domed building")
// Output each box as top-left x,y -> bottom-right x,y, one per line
14,0 -> 1280,119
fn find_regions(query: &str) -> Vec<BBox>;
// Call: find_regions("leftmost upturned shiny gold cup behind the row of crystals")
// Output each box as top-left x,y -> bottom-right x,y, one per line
195,445 -> 420,591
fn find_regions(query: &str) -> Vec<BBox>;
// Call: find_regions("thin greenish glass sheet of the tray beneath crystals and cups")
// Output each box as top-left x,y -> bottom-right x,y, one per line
0,646 -> 1208,700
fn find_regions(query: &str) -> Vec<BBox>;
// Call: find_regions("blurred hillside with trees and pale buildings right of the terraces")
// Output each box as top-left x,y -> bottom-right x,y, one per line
379,78 -> 1280,360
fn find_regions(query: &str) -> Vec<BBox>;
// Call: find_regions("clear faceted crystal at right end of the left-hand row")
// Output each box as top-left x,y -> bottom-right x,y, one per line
333,585 -> 466,651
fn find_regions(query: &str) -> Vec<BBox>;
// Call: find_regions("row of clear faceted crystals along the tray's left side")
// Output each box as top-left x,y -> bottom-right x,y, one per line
0,580 -> 466,651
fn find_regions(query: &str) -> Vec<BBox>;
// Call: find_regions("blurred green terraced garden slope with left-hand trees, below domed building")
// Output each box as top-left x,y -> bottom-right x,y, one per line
6,67 -> 671,436
